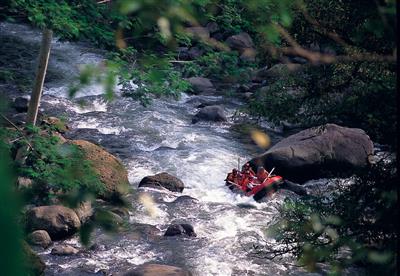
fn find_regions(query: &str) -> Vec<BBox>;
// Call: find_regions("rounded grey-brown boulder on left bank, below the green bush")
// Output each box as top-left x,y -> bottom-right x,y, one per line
26,205 -> 81,240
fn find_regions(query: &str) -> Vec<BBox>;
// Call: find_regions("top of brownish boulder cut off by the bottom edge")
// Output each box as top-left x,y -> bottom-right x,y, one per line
119,263 -> 192,276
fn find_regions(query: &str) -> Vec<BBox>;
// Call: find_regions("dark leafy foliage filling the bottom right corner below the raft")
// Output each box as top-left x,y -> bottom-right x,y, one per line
258,158 -> 398,275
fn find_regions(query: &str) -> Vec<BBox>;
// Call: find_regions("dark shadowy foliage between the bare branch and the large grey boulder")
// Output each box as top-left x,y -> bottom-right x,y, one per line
250,62 -> 397,145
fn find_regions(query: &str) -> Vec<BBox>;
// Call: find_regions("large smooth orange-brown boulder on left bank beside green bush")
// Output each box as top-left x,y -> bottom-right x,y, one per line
71,140 -> 129,198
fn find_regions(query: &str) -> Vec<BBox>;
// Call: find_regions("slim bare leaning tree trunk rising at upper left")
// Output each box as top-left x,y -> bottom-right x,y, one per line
26,29 -> 53,125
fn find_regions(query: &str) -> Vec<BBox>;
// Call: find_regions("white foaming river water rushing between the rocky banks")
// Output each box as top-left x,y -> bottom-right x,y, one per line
0,23 -> 366,275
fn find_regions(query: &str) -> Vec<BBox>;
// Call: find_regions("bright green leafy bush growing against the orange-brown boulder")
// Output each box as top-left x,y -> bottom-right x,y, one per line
0,124 -> 104,204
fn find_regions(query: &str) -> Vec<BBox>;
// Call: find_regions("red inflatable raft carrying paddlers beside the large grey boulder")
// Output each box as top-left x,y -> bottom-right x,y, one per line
225,167 -> 283,201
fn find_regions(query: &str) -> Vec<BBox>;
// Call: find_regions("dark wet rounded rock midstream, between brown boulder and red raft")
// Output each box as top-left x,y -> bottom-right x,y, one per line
139,172 -> 185,193
